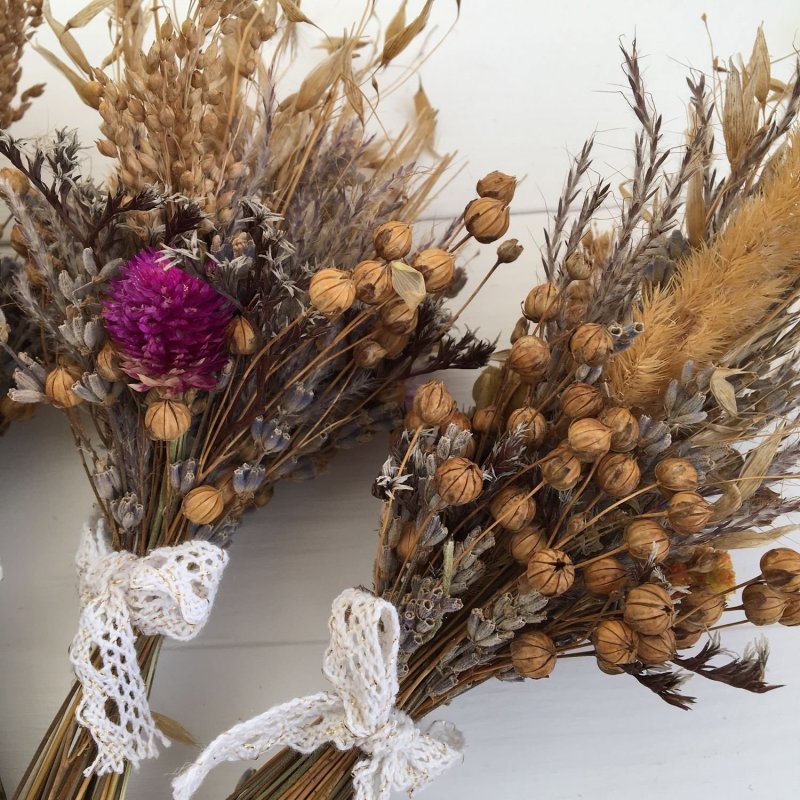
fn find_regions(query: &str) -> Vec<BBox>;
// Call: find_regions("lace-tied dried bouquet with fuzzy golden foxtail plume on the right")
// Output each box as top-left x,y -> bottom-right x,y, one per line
173,31 -> 800,800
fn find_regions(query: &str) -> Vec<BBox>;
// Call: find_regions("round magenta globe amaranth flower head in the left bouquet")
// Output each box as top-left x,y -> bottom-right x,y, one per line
103,249 -> 233,395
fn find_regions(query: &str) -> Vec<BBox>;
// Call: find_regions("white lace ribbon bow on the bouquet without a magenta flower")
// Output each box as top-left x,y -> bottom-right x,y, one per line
172,589 -> 463,800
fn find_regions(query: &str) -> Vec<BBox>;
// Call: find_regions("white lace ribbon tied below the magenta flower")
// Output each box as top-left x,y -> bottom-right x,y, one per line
70,519 -> 228,776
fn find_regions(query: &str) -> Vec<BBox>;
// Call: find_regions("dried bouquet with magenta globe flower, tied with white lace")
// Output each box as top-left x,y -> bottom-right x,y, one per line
0,0 -> 521,800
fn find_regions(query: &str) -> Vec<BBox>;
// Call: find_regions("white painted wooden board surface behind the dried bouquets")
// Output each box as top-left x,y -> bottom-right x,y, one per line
0,0 -> 800,800
